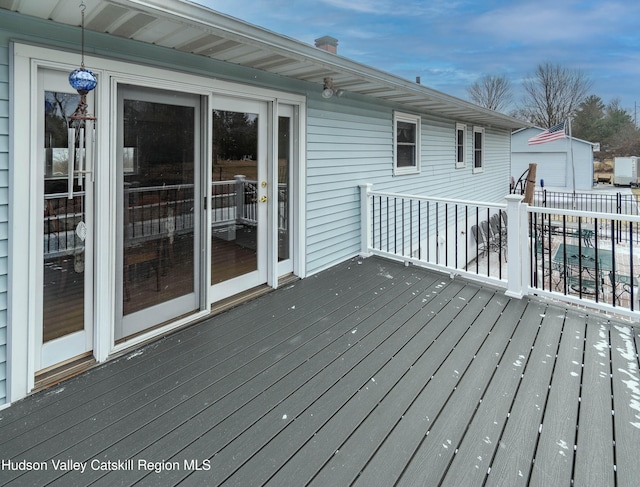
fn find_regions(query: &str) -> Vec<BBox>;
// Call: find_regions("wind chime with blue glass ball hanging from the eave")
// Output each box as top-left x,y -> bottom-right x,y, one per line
67,2 -> 98,266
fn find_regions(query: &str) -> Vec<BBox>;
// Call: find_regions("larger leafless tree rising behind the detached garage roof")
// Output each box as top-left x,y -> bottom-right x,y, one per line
520,62 -> 592,128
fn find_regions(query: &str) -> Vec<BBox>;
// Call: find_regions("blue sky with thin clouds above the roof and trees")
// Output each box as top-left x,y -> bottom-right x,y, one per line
195,0 -> 640,117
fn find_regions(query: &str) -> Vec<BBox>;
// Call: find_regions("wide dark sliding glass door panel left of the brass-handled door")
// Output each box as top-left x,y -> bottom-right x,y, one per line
116,87 -> 200,339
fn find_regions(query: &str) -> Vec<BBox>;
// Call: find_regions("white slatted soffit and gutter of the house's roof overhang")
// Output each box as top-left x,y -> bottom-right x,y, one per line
0,0 -> 528,129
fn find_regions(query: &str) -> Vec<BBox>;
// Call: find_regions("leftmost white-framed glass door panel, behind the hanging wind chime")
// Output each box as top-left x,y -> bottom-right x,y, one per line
35,70 -> 93,370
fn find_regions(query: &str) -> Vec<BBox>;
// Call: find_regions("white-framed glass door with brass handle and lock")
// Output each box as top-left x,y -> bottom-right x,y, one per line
211,100 -> 268,299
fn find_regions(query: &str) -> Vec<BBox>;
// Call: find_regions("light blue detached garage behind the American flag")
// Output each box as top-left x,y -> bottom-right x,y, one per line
511,127 -> 595,191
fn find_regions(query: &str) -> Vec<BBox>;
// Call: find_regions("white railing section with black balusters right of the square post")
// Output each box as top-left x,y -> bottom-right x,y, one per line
529,208 -> 640,311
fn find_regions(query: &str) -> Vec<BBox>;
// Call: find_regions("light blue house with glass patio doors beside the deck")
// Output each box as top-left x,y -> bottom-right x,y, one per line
0,0 -> 525,405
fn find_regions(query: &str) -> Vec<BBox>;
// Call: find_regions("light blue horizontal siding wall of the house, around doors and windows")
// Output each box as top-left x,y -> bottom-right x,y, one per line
0,12 -> 511,406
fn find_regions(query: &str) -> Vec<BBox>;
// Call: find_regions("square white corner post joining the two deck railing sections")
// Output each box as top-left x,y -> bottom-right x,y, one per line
505,194 -> 529,299
